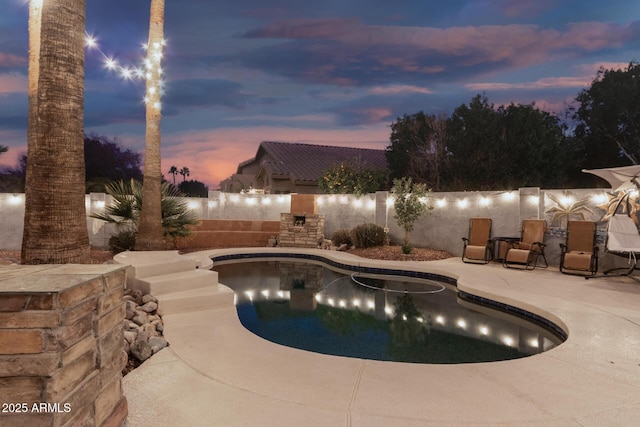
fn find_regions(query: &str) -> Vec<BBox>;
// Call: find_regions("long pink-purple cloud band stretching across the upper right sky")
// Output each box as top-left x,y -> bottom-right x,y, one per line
253,18 -> 636,72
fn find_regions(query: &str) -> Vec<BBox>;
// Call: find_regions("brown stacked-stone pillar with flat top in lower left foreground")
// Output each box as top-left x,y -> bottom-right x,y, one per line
0,264 -> 127,426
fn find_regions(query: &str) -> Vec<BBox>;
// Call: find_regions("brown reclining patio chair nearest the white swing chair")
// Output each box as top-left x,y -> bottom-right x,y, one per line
560,221 -> 599,276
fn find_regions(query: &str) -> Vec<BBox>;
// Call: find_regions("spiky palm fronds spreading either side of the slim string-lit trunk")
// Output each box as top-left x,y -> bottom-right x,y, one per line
91,180 -> 198,249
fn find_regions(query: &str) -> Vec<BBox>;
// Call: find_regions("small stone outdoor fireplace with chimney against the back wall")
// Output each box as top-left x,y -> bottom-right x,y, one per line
279,194 -> 324,248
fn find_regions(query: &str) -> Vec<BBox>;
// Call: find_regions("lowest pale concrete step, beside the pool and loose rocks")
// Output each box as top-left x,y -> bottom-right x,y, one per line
157,284 -> 234,316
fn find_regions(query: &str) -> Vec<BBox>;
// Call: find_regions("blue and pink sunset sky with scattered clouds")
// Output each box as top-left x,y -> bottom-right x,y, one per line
0,0 -> 640,189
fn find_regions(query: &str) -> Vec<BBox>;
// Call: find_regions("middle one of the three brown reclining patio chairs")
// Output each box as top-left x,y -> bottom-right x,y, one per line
504,219 -> 549,270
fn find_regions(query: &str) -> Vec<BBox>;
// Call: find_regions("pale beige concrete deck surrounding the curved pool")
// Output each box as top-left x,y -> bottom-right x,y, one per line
123,248 -> 640,427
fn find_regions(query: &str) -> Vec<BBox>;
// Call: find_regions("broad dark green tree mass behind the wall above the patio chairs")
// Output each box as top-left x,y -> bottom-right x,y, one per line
443,95 -> 568,191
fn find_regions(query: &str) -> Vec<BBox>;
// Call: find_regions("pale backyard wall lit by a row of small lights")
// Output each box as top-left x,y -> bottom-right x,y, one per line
0,187 -> 610,264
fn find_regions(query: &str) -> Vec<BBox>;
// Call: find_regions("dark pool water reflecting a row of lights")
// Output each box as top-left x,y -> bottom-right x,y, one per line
214,261 -> 560,363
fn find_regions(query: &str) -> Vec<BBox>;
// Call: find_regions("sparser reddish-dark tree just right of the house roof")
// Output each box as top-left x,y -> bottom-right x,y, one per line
385,111 -> 449,191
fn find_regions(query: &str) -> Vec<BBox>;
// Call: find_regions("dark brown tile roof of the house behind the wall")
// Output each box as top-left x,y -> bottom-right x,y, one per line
255,141 -> 388,182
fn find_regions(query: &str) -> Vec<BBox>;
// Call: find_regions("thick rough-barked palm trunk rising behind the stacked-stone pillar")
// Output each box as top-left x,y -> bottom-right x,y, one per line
22,0 -> 90,264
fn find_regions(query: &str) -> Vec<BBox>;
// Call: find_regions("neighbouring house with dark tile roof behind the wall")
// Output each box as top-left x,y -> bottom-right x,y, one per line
220,141 -> 388,194
